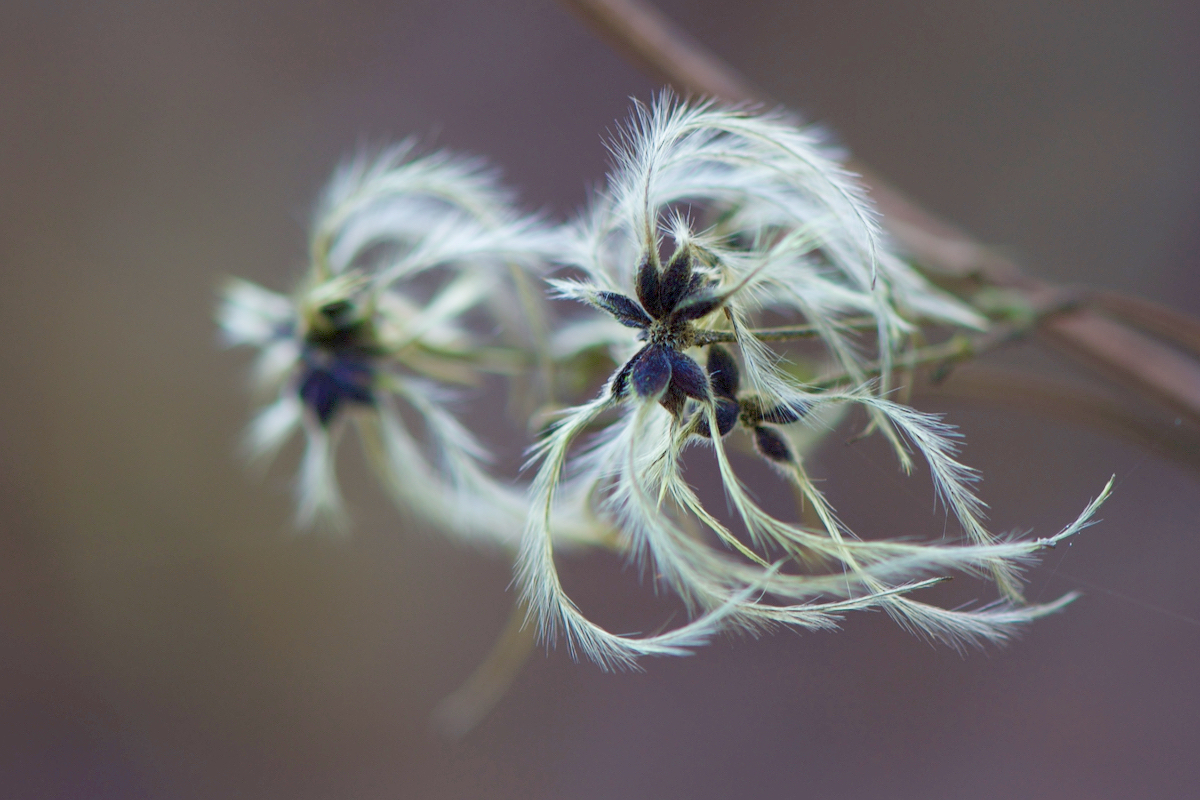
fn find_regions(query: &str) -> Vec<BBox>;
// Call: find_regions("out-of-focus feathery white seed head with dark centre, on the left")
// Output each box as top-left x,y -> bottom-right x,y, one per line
218,142 -> 595,545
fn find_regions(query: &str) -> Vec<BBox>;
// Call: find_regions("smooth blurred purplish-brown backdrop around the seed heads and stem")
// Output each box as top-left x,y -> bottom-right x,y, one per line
0,0 -> 1200,799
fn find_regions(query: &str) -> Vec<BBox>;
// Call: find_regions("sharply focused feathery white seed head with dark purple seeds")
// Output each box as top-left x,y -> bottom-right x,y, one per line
517,95 -> 1111,668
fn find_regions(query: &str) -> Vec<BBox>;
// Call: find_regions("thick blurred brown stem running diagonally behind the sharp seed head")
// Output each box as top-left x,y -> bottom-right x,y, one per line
562,0 -> 1200,422
